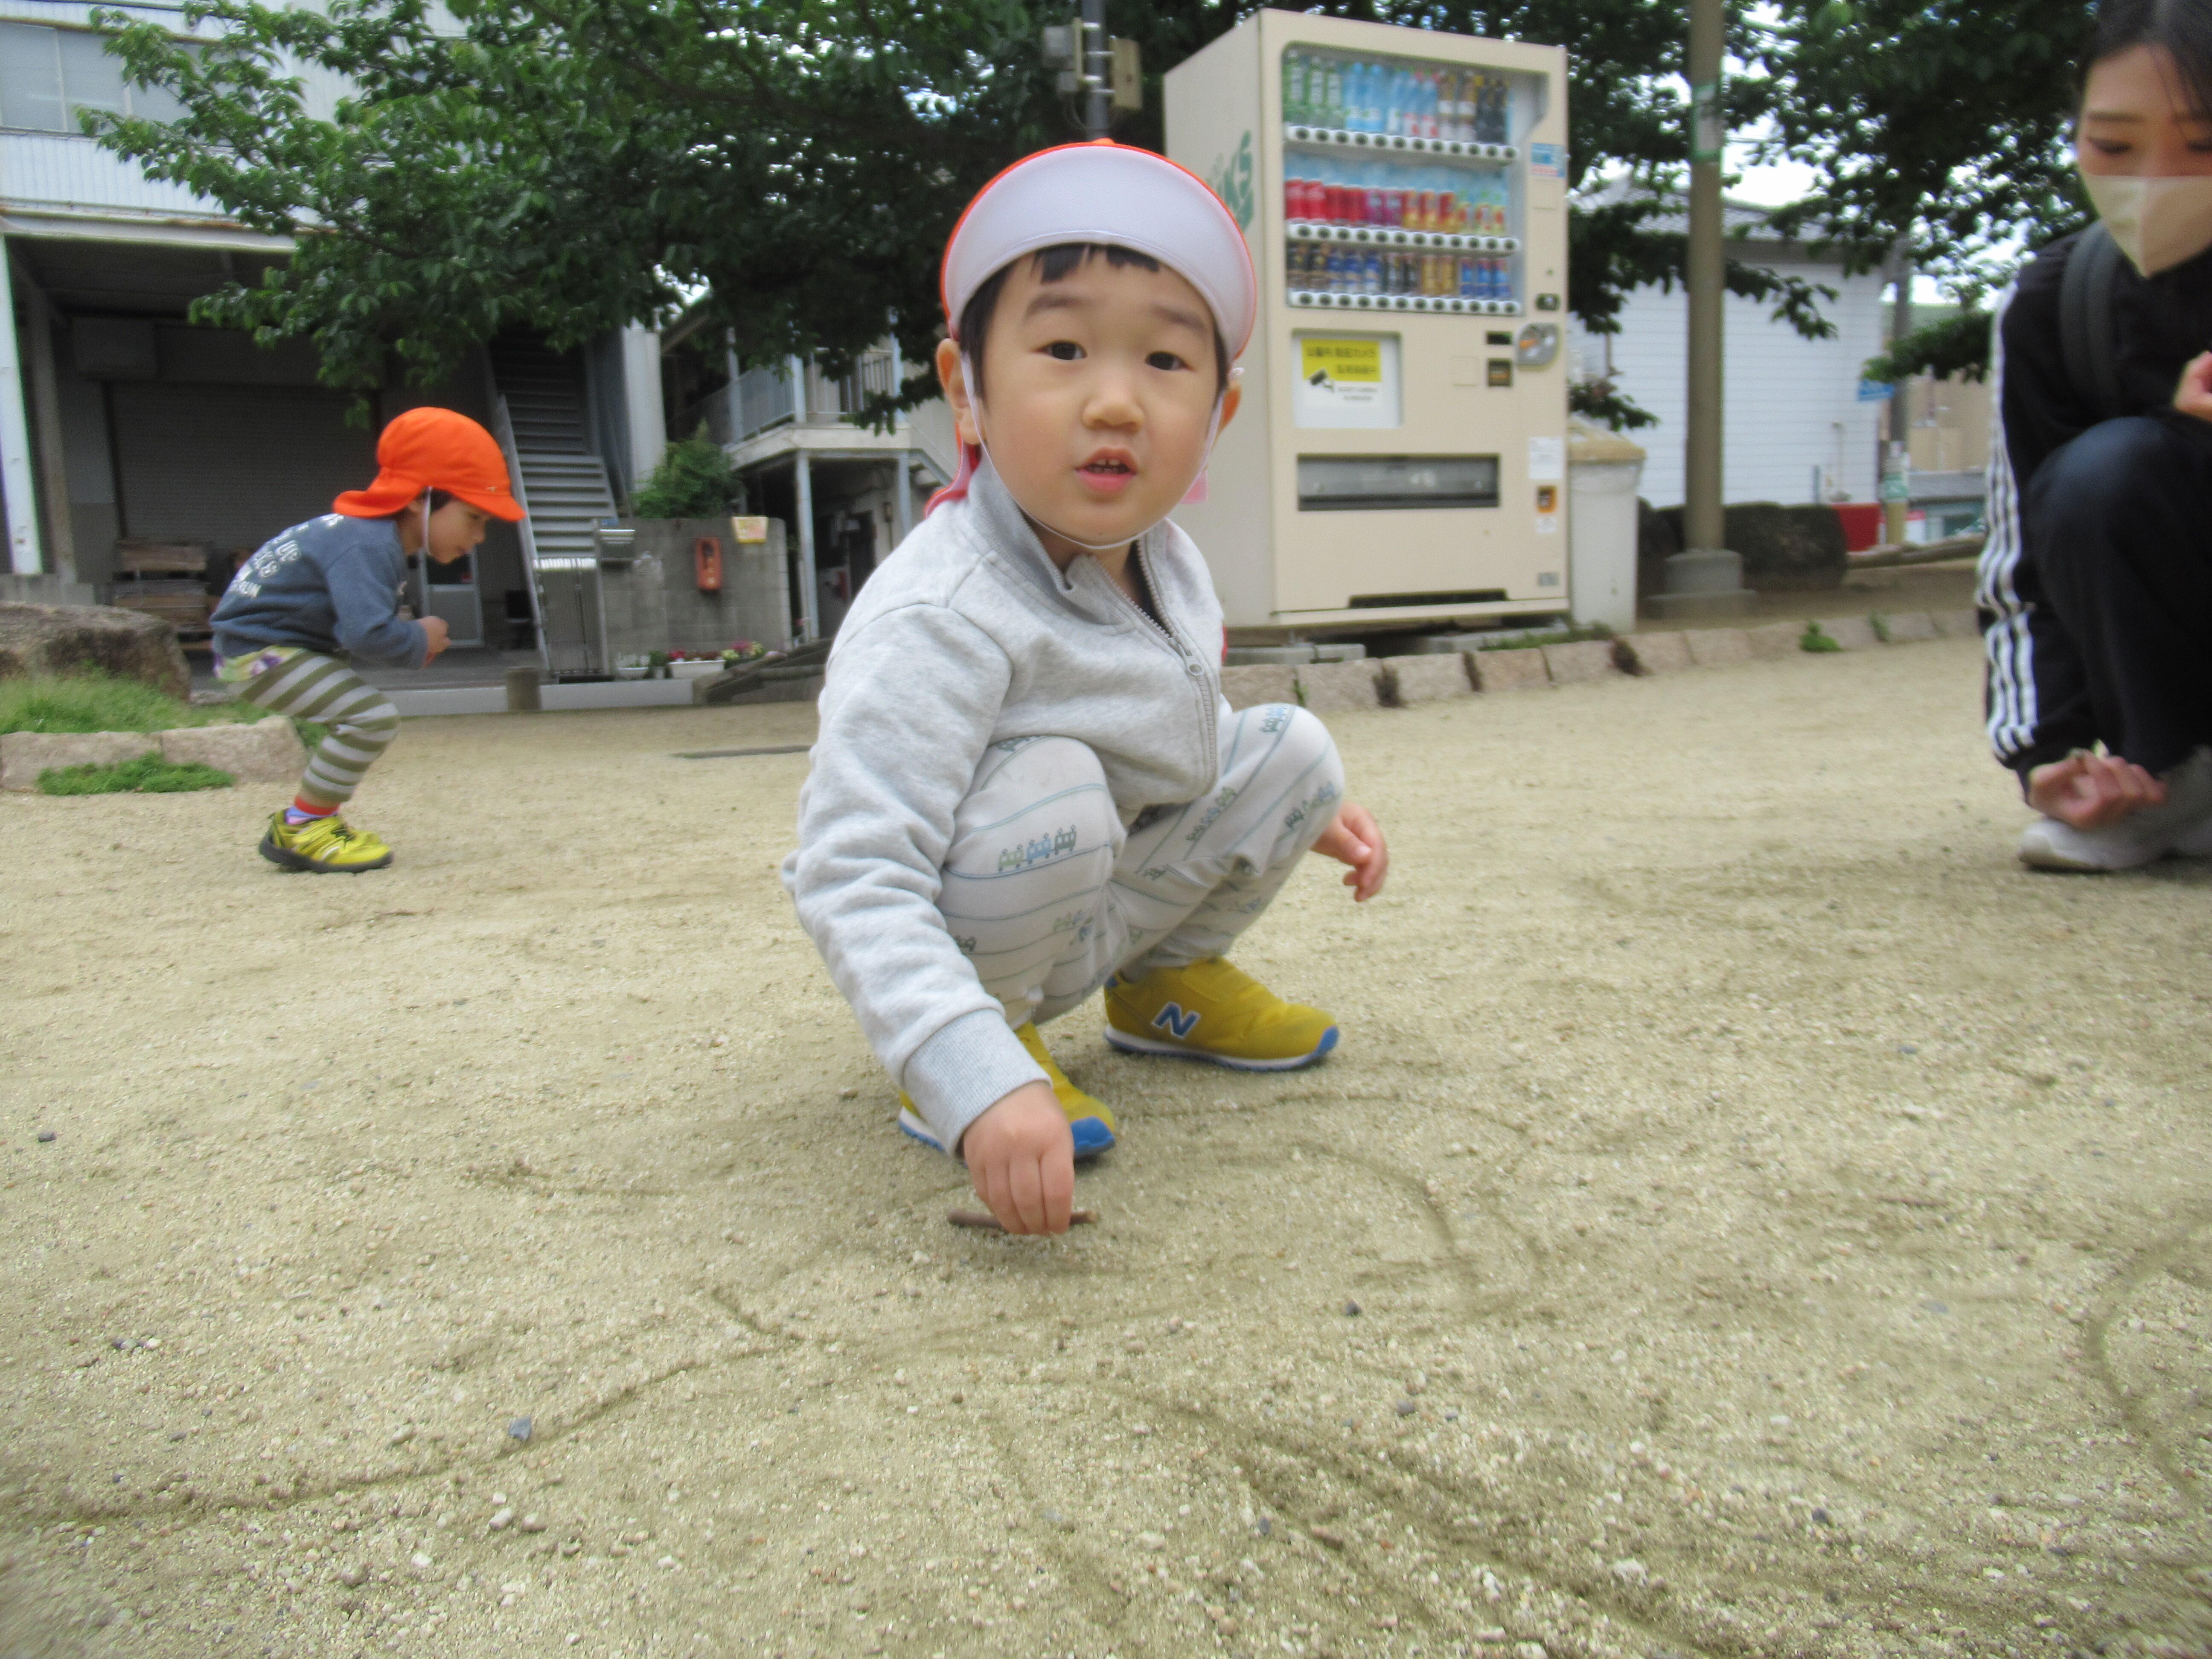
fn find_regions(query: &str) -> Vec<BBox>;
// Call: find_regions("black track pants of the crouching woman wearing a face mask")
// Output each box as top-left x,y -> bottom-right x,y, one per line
2022,416 -> 2212,772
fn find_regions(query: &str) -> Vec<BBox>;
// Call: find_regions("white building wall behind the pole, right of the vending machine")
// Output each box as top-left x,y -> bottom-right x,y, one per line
1573,261 -> 1883,506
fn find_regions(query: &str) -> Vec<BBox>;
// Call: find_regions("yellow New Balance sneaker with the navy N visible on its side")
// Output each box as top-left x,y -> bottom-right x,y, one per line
1106,955 -> 1336,1071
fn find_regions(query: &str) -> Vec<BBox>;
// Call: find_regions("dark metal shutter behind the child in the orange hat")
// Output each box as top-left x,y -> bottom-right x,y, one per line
108,383 -> 376,549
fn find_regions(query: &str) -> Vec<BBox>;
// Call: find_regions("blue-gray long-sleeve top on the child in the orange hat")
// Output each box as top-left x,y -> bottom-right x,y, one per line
210,513 -> 429,668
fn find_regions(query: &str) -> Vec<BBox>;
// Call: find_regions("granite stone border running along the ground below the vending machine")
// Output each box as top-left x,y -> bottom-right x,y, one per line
1247,611 -> 1980,714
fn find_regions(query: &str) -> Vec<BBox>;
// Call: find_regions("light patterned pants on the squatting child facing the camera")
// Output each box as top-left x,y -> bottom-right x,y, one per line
938,704 -> 1345,1026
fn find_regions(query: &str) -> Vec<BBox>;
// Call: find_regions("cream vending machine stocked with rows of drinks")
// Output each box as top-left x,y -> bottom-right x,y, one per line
1166,11 -> 1568,630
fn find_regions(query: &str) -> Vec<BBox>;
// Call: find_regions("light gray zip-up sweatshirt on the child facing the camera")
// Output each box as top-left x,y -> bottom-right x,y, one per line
783,462 -> 1225,1146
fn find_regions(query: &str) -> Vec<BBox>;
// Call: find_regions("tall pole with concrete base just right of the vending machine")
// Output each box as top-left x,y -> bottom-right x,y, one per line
1650,0 -> 1752,617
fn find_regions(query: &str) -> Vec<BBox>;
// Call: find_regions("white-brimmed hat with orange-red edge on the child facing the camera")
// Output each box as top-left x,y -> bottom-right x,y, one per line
929,140 -> 1259,520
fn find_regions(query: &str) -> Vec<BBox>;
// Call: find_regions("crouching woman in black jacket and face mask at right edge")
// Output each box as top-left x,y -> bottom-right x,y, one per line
1980,0 -> 2212,869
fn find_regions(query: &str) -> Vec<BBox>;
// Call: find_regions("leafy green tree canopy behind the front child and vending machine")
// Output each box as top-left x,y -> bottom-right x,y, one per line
95,0 -> 1825,429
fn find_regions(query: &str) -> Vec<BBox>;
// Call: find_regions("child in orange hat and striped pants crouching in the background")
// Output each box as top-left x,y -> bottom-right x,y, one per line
212,409 -> 522,874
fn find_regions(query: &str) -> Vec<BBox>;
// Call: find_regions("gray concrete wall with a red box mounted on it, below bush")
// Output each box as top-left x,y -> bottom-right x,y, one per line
606,518 -> 792,655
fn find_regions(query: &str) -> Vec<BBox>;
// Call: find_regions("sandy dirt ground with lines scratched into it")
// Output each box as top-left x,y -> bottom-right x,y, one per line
0,641 -> 2212,1659
